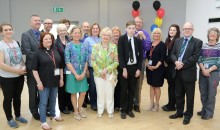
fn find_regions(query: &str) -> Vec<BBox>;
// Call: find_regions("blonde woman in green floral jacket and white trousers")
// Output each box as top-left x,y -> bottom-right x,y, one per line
91,27 -> 119,118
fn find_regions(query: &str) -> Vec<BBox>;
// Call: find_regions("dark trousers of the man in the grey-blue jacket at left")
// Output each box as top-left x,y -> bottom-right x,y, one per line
27,70 -> 39,115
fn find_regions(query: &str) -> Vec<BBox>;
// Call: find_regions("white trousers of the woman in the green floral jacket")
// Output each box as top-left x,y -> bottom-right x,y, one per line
94,75 -> 115,114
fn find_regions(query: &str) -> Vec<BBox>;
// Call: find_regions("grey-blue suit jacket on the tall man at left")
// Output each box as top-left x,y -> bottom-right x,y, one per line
21,29 -> 40,70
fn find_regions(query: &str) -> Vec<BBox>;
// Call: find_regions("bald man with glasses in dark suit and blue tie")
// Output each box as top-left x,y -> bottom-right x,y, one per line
169,22 -> 202,125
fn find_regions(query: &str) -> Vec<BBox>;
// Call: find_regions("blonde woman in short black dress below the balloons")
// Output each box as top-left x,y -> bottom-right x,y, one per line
146,28 -> 166,111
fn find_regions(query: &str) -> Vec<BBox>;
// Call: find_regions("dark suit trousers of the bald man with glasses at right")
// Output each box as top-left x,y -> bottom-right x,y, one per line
175,71 -> 195,119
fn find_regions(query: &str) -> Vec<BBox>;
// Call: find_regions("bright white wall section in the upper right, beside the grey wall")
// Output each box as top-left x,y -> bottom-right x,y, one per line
186,0 -> 220,42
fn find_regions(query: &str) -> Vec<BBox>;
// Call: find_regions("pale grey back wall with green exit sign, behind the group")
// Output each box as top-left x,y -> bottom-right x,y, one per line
0,0 -> 186,41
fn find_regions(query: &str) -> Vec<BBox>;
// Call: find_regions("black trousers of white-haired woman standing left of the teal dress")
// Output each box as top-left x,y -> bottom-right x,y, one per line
58,74 -> 73,112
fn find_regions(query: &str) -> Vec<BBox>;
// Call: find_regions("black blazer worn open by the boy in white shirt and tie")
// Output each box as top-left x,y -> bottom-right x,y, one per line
118,34 -> 143,70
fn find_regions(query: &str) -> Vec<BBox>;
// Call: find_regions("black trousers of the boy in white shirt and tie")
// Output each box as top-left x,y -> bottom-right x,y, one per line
120,65 -> 137,113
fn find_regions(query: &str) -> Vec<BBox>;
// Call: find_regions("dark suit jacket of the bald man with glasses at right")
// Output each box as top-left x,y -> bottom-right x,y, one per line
171,37 -> 202,82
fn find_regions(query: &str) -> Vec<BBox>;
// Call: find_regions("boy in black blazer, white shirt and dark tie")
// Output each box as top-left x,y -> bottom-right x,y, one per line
118,21 -> 143,119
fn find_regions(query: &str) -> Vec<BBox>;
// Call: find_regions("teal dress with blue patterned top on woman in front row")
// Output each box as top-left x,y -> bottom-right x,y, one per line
65,42 -> 88,94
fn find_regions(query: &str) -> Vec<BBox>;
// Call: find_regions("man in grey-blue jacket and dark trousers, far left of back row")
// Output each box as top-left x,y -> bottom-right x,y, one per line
21,15 -> 41,120
